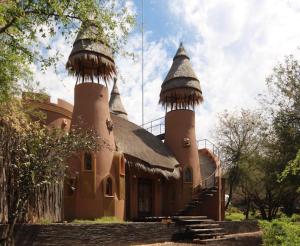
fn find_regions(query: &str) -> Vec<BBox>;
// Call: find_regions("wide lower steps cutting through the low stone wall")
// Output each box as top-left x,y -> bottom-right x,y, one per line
172,216 -> 225,244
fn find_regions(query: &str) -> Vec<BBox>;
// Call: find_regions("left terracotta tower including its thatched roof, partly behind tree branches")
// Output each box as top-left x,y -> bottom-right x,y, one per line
64,22 -> 124,219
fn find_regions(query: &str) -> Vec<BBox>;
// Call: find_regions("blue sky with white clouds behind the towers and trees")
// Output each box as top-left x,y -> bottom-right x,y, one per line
34,0 -> 300,142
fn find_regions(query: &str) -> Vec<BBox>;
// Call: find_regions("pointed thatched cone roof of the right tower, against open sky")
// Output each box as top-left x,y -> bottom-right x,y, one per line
159,43 -> 203,107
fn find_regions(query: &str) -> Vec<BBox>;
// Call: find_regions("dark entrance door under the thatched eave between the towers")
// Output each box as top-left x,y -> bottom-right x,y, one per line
138,179 -> 153,217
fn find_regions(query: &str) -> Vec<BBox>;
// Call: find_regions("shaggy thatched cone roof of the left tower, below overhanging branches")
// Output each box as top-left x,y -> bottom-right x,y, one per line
66,24 -> 116,83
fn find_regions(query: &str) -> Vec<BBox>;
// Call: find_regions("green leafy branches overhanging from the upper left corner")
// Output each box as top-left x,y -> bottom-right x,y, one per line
0,0 -> 134,102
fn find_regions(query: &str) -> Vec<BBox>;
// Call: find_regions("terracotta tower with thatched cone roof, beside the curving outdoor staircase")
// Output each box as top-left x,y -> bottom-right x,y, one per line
160,43 -> 203,207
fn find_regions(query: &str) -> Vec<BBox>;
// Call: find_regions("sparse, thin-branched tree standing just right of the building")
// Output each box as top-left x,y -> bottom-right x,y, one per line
215,110 -> 265,208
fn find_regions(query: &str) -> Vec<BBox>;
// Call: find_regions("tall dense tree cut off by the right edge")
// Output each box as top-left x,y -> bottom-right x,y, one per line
265,55 -> 300,215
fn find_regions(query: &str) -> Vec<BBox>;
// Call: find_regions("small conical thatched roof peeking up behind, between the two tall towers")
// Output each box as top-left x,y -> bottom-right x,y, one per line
109,79 -> 128,120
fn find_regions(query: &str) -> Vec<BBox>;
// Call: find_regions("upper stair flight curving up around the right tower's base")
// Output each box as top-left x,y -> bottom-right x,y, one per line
175,186 -> 217,216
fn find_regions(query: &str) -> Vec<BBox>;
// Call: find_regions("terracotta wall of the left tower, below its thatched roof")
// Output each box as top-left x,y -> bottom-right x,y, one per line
65,83 -> 124,219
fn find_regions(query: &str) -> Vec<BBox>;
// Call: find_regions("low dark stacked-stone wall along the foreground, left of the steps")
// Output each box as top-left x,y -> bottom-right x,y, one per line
0,222 -> 178,246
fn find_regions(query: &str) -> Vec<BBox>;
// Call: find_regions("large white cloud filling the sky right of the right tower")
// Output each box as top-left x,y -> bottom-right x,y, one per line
169,0 -> 300,141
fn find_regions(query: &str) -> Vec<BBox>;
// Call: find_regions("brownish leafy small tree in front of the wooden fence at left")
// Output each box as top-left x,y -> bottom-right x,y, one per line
0,100 -> 107,245
